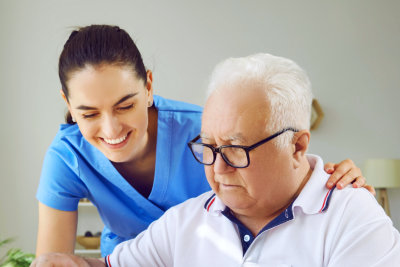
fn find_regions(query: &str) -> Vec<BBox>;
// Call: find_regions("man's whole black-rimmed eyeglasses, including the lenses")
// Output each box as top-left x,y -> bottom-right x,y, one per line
188,128 -> 298,168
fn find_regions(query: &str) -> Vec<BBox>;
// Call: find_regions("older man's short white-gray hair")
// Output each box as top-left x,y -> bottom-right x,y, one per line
207,54 -> 313,148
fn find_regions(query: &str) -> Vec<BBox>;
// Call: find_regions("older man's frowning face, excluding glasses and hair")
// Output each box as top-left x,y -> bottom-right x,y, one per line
201,86 -> 297,220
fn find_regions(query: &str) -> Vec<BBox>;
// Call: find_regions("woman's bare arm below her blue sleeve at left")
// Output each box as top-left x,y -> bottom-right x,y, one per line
36,202 -> 78,256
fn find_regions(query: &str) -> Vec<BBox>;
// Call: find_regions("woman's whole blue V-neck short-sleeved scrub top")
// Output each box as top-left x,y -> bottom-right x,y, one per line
36,95 -> 210,256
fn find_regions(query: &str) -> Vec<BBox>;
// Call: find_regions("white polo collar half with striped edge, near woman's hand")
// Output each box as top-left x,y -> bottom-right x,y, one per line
293,155 -> 335,214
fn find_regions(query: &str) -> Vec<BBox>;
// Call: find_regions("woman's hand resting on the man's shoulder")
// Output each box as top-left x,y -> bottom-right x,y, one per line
324,159 -> 375,195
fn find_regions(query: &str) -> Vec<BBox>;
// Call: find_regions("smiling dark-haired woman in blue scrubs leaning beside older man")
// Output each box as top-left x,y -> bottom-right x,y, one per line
36,25 -> 363,256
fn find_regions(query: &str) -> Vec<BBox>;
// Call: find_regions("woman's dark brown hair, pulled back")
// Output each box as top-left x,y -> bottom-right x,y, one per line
58,25 -> 147,124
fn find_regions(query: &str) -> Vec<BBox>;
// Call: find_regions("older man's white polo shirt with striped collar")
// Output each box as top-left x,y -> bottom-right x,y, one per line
105,155 -> 400,267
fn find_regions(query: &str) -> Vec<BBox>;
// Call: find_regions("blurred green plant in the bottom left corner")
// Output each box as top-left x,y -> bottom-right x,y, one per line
0,238 -> 35,267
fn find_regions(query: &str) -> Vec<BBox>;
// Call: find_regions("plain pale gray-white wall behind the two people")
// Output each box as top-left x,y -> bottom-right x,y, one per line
0,0 -> 400,255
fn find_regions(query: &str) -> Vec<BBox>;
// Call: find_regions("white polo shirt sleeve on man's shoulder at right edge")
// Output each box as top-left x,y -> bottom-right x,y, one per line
328,189 -> 400,266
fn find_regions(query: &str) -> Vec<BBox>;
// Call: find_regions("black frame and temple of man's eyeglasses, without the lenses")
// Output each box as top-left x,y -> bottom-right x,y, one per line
188,127 -> 299,169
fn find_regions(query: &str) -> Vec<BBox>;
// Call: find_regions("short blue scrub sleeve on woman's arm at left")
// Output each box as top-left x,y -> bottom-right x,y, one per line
36,142 -> 87,211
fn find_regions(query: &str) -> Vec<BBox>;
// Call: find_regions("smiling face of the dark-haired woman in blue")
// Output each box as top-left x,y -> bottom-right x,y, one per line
64,64 -> 153,162
